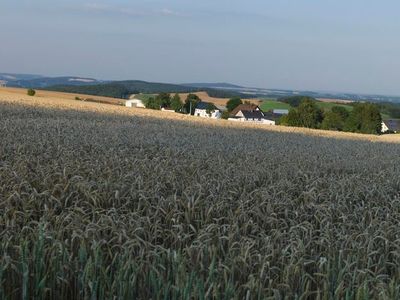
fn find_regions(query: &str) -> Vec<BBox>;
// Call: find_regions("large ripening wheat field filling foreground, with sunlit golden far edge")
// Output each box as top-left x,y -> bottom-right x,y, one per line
0,89 -> 400,299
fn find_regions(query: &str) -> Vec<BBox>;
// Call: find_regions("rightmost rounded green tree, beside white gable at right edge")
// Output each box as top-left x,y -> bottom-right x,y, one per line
344,103 -> 382,134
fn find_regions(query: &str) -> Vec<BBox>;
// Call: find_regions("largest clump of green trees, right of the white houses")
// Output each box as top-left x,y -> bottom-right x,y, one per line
280,98 -> 382,134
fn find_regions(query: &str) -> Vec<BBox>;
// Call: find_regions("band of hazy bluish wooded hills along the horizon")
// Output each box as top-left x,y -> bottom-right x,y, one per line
4,73 -> 400,103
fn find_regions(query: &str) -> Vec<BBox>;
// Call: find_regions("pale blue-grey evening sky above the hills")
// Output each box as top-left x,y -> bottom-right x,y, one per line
0,0 -> 400,95
